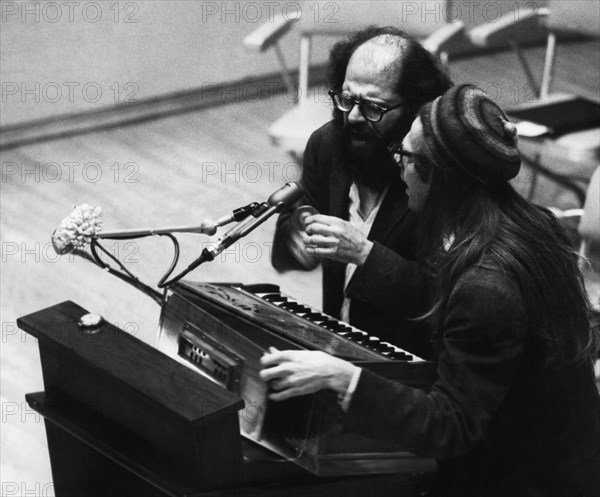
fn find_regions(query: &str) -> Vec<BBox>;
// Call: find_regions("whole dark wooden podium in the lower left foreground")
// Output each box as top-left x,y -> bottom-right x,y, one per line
17,302 -> 426,497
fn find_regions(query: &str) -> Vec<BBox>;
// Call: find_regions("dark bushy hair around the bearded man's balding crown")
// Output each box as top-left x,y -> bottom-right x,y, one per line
329,26 -> 452,122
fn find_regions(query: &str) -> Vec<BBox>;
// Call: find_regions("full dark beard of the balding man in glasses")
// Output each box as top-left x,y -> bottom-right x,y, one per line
340,126 -> 399,192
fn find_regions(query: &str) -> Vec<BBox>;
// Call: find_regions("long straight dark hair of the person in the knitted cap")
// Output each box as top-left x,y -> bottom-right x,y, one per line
415,149 -> 595,361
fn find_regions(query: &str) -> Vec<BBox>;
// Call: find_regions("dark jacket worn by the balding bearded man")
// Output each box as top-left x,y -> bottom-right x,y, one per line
273,122 -> 432,358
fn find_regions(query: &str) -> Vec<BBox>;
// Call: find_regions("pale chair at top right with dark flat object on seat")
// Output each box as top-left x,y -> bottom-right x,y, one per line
467,0 -> 600,205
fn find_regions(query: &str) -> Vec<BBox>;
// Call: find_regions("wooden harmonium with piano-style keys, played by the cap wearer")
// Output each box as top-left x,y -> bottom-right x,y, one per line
158,281 -> 436,476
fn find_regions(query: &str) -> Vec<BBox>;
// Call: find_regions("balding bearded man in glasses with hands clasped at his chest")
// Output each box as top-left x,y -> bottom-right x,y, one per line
273,27 -> 451,358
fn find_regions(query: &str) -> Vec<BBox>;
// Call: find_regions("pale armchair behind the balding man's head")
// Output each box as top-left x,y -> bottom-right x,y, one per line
244,0 -> 454,164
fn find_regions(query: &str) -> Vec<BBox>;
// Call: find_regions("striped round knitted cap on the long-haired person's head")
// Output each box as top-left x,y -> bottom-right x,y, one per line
419,84 -> 521,184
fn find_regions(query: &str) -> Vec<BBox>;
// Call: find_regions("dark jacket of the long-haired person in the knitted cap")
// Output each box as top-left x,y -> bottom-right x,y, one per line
344,266 -> 600,497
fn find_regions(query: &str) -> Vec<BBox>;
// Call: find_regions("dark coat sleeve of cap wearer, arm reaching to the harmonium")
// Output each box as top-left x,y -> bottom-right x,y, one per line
344,272 -> 526,459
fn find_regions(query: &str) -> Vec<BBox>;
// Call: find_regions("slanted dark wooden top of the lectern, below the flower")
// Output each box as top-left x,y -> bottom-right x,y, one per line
17,301 -> 244,426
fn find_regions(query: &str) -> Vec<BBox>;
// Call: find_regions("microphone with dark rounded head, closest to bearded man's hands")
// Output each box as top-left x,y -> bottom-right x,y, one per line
200,183 -> 304,262
